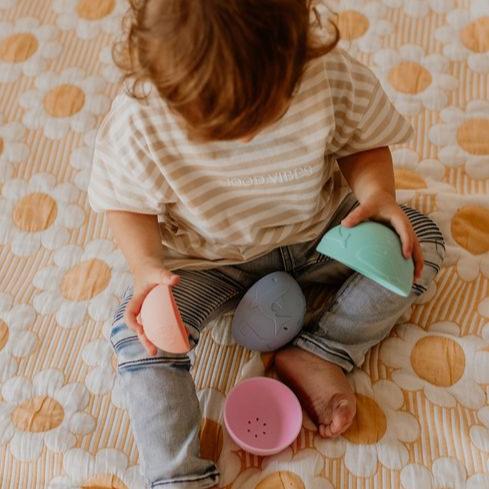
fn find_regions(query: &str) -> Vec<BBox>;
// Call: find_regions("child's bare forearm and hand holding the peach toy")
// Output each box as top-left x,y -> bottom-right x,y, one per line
107,210 -> 180,355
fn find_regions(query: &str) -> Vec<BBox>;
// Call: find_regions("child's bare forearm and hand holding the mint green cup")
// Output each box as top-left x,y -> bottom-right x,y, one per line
338,146 -> 423,279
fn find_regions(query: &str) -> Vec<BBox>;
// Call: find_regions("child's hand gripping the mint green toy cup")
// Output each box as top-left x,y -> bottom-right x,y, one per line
341,194 -> 424,280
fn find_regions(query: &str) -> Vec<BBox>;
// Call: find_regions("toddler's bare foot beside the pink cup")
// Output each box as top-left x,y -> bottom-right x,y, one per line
275,346 -> 356,438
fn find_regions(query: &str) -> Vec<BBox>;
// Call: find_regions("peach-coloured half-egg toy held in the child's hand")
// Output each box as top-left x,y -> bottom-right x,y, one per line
140,284 -> 190,353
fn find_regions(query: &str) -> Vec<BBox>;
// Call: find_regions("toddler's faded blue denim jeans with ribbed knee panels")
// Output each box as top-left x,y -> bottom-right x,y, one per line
110,194 -> 445,489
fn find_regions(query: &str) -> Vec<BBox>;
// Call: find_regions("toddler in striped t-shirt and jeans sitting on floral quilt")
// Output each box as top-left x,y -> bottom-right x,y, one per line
88,0 -> 444,489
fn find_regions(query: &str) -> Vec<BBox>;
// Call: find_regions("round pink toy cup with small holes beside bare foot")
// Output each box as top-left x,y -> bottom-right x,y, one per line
224,377 -> 302,455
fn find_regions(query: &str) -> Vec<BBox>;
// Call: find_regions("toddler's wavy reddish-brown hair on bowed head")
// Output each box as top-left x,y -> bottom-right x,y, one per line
113,0 -> 339,141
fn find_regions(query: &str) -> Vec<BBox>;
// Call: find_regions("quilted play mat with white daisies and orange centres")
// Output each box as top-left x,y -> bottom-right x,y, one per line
0,0 -> 489,489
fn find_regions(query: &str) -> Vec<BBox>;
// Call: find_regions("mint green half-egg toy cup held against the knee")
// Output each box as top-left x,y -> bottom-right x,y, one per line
316,221 -> 414,297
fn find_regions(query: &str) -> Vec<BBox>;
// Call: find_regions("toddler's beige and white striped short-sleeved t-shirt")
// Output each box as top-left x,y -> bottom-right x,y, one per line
88,48 -> 412,270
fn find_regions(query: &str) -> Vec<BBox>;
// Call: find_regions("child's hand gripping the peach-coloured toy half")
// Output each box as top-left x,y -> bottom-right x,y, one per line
124,260 -> 180,356
